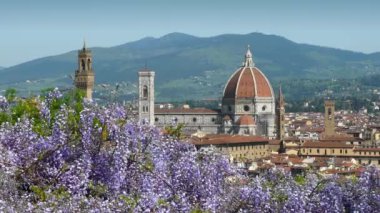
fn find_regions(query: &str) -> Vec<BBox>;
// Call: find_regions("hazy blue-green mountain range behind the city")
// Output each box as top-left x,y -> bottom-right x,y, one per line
0,33 -> 380,100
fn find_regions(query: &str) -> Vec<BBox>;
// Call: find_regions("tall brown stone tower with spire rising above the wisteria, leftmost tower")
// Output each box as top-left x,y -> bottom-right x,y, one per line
75,43 -> 95,99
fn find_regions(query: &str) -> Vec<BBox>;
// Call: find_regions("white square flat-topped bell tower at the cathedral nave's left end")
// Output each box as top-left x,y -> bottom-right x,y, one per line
139,68 -> 155,125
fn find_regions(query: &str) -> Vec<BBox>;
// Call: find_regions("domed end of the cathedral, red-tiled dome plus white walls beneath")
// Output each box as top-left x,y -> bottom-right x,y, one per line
222,47 -> 275,137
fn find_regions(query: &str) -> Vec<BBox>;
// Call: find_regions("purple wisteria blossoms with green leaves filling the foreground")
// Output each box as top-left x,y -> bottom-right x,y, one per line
0,90 -> 380,212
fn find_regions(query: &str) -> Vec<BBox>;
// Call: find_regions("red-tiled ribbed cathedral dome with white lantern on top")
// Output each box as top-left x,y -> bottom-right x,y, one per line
223,47 -> 274,99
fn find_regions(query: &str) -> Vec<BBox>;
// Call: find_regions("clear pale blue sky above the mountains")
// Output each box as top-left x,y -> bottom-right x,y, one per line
0,0 -> 380,66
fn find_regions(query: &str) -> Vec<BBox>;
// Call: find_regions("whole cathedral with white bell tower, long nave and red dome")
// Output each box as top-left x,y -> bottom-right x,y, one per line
138,46 -> 284,138
